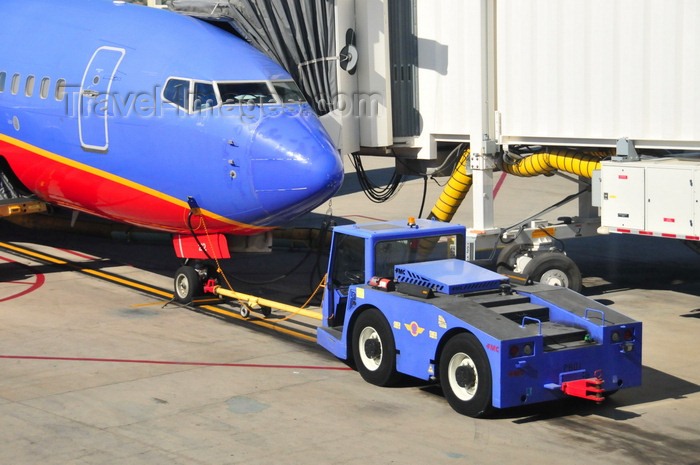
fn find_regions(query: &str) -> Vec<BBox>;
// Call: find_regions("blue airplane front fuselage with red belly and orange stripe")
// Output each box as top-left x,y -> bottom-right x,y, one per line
0,0 -> 343,234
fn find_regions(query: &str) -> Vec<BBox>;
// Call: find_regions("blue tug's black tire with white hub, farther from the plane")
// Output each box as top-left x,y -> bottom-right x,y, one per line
439,333 -> 492,418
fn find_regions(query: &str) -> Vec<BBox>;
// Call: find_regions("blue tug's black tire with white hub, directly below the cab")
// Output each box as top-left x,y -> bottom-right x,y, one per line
352,308 -> 399,386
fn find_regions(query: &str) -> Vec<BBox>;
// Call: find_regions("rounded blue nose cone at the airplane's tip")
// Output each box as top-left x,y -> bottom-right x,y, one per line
249,112 -> 343,226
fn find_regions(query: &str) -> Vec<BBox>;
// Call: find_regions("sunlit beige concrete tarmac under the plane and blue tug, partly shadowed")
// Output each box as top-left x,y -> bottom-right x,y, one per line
0,159 -> 700,465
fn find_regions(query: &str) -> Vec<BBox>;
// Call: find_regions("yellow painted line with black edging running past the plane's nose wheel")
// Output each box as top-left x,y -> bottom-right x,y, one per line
0,242 -> 316,342
